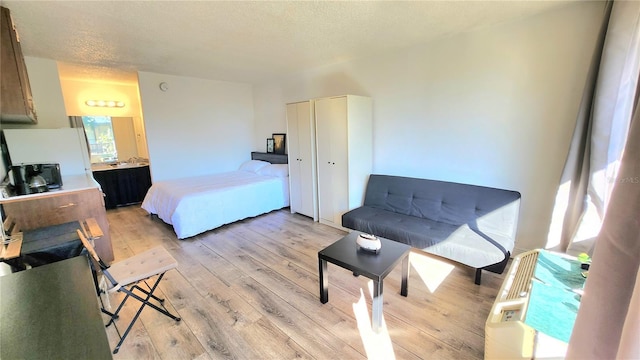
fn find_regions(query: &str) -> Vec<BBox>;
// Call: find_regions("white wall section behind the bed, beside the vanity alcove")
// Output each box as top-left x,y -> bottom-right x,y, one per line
138,72 -> 255,182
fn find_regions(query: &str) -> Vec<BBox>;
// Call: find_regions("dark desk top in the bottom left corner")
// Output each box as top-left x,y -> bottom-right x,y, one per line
0,256 -> 112,359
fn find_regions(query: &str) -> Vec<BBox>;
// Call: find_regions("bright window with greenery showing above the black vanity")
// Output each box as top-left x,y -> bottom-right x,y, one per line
82,116 -> 118,163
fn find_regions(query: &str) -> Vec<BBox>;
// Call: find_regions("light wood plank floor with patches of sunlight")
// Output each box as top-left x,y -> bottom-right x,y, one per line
107,206 -> 502,359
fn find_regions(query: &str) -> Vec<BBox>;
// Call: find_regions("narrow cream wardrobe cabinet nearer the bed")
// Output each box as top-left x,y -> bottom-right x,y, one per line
287,101 -> 318,221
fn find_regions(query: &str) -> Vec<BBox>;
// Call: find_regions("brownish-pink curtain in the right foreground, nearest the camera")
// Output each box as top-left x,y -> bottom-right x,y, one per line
567,80 -> 640,359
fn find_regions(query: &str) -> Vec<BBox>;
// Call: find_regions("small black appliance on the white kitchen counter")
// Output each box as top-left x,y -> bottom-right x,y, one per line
9,164 -> 62,195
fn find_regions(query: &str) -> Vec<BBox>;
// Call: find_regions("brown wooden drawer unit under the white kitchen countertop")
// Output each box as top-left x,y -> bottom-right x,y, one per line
2,188 -> 114,262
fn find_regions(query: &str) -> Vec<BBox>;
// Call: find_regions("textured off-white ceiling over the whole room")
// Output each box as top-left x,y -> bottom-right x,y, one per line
2,0 -> 572,83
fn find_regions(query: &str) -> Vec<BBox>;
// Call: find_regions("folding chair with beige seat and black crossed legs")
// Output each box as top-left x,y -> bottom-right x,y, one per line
77,230 -> 180,354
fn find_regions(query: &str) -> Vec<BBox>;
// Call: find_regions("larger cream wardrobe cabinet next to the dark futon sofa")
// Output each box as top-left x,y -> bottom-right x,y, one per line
314,95 -> 373,228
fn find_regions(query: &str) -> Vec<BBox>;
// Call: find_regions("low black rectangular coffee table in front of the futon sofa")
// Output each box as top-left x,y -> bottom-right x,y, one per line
318,231 -> 411,332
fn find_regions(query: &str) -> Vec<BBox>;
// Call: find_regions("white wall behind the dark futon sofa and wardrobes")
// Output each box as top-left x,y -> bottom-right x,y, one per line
254,2 -> 603,252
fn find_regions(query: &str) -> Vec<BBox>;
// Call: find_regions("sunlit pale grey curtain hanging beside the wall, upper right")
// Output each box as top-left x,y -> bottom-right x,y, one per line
547,1 -> 640,255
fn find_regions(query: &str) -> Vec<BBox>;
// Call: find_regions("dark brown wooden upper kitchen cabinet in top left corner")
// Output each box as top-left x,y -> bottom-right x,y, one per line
0,7 -> 38,124
